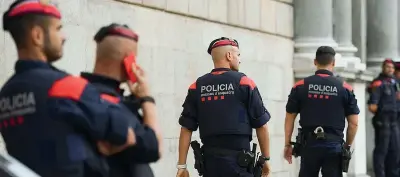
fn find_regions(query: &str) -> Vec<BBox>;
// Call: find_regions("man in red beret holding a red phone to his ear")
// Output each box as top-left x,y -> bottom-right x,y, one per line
81,24 -> 162,177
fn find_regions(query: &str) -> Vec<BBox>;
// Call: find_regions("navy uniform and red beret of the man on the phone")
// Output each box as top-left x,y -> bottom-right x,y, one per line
81,24 -> 160,177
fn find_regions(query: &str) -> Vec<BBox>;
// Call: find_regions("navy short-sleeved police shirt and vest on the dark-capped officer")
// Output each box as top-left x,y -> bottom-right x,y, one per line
286,70 -> 360,147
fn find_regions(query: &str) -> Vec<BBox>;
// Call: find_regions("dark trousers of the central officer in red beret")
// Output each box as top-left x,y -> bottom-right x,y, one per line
204,153 -> 254,177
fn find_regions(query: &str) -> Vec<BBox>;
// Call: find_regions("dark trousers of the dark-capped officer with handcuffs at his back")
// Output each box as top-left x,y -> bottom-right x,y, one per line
299,146 -> 343,177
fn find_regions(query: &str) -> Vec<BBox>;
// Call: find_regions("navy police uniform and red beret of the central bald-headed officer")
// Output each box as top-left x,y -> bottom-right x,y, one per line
179,38 -> 270,177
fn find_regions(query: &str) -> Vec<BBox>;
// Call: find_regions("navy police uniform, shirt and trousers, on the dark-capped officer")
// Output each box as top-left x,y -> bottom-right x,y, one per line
286,65 -> 360,177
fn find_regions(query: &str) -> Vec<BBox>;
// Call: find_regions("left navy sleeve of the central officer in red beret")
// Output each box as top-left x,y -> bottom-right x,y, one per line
179,83 -> 199,131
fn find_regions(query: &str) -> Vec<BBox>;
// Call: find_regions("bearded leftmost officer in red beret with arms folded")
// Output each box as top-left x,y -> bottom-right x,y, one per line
0,0 -> 136,177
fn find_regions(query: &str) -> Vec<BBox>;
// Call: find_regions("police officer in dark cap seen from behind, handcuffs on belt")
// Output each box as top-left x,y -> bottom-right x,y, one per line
284,46 -> 360,177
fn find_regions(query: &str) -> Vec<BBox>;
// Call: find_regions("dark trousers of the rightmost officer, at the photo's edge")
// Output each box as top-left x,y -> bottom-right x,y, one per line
372,112 -> 400,177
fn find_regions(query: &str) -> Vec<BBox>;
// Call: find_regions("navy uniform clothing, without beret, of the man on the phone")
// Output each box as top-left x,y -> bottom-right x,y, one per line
81,73 -> 160,177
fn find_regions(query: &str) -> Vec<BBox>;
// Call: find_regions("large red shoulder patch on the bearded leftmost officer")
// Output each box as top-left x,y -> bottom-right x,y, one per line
48,75 -> 88,101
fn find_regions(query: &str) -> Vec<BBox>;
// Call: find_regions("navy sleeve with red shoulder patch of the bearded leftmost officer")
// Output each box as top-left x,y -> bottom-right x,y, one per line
47,77 -> 131,145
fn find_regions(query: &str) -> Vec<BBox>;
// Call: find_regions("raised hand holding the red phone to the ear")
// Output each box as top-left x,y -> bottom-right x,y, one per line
128,65 -> 150,98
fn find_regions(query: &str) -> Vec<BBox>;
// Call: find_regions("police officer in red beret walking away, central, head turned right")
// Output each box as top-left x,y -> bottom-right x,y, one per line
177,37 -> 270,177
